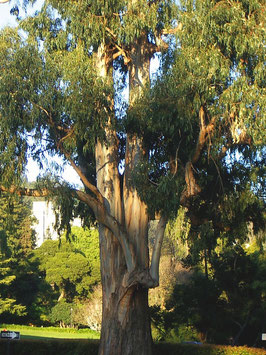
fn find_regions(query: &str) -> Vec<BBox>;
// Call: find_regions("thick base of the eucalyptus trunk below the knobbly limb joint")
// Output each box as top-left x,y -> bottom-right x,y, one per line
99,287 -> 152,355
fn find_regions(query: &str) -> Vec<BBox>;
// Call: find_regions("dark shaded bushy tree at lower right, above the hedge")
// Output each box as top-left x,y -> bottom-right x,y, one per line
167,246 -> 265,345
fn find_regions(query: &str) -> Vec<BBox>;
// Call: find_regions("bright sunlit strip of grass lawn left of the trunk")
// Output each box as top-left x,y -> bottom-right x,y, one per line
0,324 -> 100,339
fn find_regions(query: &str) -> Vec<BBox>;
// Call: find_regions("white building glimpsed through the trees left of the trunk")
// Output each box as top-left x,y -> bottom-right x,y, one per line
32,200 -> 81,248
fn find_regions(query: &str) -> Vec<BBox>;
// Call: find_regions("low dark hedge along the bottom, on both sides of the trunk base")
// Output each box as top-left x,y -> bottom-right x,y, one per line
0,339 -> 266,355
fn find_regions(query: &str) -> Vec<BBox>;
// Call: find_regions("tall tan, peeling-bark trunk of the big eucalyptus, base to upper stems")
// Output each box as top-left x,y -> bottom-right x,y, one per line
95,34 -> 152,355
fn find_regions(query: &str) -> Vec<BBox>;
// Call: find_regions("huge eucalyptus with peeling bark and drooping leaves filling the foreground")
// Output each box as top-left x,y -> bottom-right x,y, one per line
0,0 -> 264,354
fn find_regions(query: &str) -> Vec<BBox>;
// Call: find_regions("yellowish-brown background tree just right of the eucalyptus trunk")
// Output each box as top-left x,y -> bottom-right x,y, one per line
149,207 -> 191,340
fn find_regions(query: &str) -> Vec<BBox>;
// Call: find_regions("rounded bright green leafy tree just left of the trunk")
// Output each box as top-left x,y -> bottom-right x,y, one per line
34,227 -> 100,302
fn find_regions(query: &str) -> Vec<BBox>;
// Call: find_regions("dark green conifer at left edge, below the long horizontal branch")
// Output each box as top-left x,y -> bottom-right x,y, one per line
0,193 -> 52,323
